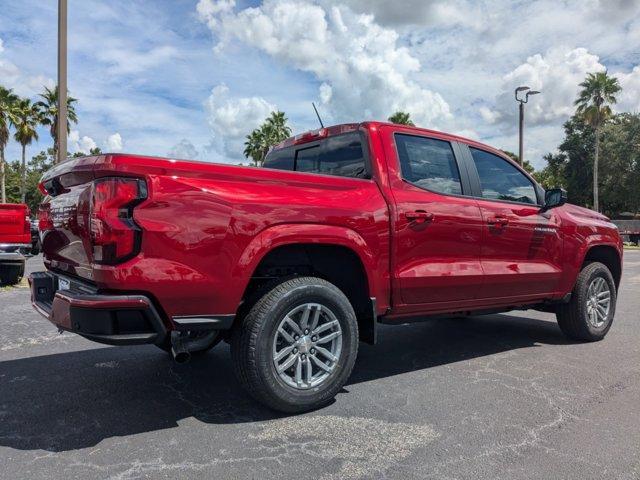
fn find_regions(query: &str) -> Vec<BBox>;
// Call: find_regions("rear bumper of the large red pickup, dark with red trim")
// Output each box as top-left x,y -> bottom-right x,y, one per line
29,272 -> 167,345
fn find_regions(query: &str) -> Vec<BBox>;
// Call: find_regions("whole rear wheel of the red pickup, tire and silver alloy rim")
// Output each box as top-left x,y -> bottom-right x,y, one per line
231,277 -> 358,413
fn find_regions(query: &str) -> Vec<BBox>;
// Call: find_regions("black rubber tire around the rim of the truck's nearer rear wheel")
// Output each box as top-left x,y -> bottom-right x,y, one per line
231,277 -> 358,413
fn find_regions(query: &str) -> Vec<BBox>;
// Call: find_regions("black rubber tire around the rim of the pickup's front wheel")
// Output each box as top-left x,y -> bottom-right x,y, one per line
556,262 -> 617,342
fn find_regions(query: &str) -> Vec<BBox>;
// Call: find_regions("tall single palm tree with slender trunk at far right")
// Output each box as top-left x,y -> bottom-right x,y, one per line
575,71 -> 622,211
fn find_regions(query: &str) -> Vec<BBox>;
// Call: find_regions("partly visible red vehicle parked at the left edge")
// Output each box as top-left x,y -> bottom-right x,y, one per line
0,203 -> 31,285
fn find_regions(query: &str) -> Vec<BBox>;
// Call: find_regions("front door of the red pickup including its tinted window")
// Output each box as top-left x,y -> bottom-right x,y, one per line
461,145 -> 562,300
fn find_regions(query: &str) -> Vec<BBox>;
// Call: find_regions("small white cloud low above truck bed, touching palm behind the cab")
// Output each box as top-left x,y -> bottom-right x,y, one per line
205,85 -> 277,160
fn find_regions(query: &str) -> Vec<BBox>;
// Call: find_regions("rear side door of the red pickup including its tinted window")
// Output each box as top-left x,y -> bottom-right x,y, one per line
381,127 -> 482,313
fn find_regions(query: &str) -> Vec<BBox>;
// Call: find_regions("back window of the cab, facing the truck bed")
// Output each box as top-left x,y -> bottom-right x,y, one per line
264,132 -> 368,178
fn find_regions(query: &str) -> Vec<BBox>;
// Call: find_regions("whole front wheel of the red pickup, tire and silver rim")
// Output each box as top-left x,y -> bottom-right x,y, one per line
556,262 -> 616,342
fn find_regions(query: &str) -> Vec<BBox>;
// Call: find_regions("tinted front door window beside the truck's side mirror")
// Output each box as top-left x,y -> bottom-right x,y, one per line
470,148 -> 538,204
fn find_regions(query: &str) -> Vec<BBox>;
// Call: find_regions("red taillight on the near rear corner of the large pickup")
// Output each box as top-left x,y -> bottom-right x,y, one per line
89,177 -> 147,264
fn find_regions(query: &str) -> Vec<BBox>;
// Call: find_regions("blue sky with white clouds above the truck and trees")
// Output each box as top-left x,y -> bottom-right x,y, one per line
0,0 -> 640,168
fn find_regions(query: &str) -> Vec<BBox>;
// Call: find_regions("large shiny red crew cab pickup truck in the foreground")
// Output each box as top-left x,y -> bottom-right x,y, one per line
30,122 -> 622,412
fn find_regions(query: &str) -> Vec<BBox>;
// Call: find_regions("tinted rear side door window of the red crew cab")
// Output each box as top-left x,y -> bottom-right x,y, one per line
396,134 -> 462,195
